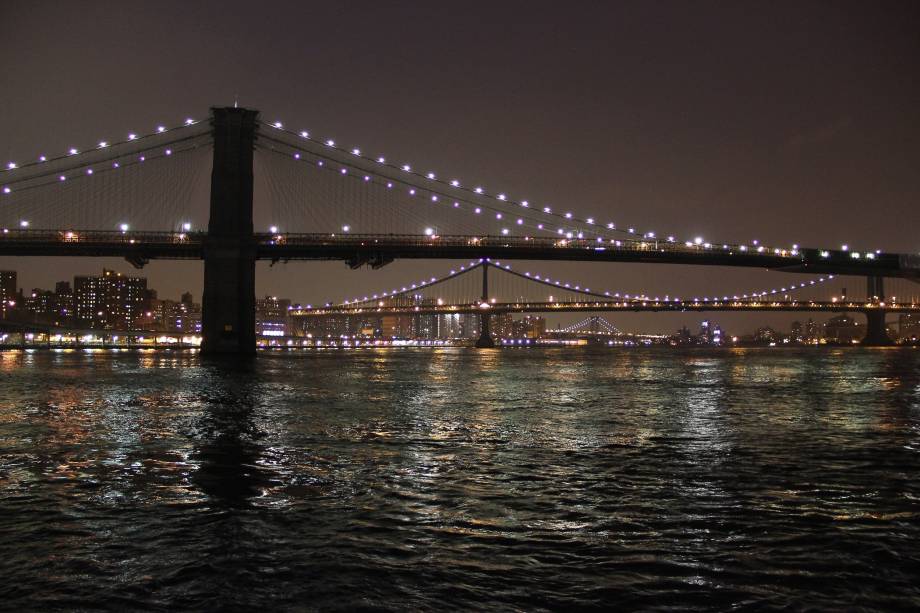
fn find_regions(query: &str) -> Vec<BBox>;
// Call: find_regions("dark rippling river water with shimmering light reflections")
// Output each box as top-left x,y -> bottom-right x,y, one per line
0,349 -> 920,611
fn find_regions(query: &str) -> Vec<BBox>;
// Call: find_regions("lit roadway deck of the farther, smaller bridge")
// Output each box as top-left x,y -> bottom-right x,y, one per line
290,300 -> 920,317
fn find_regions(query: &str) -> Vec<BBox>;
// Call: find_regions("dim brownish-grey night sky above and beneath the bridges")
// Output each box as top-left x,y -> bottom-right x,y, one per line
0,1 -> 920,331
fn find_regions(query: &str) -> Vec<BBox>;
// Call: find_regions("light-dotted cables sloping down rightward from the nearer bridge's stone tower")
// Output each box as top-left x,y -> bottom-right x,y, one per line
252,115 -> 812,252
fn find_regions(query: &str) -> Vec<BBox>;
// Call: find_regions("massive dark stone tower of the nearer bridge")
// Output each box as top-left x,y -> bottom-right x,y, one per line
201,107 -> 259,355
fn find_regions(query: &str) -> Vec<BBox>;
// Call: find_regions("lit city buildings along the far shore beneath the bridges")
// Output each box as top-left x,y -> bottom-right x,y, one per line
0,260 -> 920,346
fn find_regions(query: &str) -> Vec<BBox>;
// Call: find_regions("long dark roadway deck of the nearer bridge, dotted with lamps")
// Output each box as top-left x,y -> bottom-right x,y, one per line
0,228 -> 920,279
